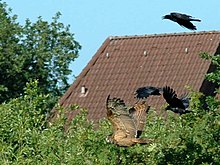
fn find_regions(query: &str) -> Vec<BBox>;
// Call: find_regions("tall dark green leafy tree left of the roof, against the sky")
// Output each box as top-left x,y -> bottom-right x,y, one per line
0,1 -> 81,103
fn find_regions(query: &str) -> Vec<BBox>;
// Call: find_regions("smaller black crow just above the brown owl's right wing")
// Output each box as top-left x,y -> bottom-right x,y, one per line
135,86 -> 162,99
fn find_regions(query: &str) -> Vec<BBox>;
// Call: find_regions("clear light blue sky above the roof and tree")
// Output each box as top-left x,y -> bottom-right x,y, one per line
5,0 -> 220,82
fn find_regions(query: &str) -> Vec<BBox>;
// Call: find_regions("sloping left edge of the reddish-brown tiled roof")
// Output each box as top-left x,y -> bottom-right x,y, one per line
59,37 -> 111,105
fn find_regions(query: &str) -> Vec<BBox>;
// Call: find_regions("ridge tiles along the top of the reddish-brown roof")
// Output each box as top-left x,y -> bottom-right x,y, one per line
108,30 -> 220,40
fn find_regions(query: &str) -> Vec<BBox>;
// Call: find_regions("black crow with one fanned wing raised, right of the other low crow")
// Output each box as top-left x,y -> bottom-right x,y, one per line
163,86 -> 192,115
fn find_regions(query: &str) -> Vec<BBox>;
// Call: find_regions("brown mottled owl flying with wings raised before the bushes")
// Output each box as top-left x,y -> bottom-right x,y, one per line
106,95 -> 152,147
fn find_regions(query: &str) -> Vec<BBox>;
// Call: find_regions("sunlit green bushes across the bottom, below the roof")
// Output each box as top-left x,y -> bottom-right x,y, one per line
0,81 -> 220,164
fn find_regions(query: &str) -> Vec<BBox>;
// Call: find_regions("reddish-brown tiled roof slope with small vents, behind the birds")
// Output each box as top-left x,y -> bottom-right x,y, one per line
60,31 -> 220,120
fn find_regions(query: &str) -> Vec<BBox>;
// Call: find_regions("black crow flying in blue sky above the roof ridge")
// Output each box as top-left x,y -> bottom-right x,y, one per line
162,13 -> 201,30
